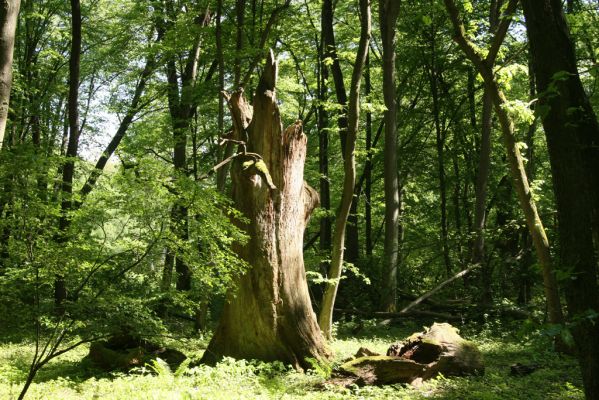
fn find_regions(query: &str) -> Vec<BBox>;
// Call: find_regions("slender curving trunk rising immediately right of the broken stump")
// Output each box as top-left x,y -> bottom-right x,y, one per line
318,0 -> 371,339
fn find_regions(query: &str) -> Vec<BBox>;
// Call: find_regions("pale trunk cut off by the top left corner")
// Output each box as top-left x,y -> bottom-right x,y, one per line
0,0 -> 21,149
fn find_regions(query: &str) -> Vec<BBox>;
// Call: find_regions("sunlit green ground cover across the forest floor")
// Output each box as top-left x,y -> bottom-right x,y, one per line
0,321 -> 584,400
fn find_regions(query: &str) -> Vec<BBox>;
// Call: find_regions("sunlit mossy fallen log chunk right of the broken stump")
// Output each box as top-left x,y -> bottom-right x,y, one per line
334,323 -> 485,385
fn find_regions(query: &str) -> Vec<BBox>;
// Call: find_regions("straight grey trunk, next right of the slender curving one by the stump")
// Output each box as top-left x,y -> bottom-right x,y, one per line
379,0 -> 401,312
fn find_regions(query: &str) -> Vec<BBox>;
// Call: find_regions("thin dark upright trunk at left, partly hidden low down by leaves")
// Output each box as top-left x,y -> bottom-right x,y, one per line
54,0 -> 81,308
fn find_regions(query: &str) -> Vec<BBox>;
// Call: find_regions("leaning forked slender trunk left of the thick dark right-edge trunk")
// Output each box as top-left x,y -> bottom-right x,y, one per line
444,0 -> 563,324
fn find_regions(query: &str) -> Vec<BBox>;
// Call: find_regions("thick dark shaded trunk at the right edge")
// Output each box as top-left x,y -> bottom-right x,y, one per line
522,0 -> 599,399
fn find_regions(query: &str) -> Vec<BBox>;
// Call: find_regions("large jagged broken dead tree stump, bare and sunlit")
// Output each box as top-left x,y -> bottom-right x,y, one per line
202,52 -> 329,368
